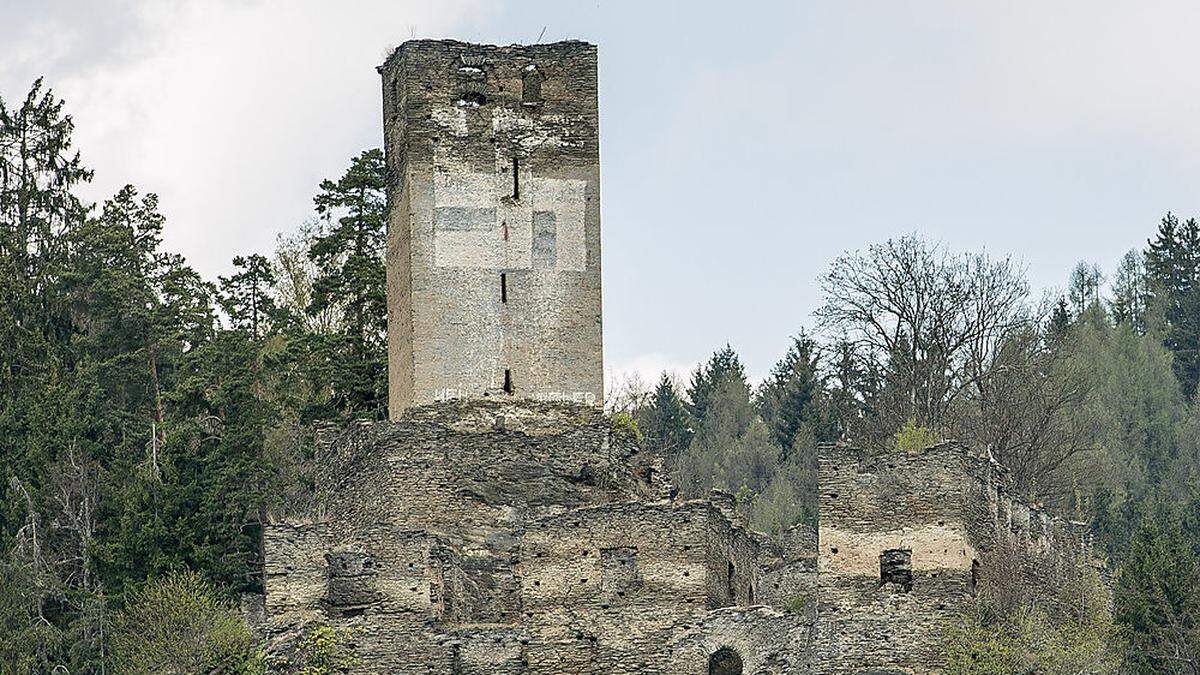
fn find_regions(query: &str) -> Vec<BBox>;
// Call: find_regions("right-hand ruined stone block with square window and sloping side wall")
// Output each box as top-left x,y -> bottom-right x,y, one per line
816,443 -> 1096,673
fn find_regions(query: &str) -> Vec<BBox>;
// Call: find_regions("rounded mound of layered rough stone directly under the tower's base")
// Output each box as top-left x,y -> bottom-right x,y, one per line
319,401 -> 660,546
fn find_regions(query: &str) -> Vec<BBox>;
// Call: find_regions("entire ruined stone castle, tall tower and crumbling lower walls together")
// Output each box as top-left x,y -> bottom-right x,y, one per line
259,41 -> 1093,675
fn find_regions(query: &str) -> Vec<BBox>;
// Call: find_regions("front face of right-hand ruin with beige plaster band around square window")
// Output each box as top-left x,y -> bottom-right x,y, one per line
817,446 -> 976,673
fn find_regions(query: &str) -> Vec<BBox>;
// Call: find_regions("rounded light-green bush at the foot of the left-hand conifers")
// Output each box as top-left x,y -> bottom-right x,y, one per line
112,572 -> 265,675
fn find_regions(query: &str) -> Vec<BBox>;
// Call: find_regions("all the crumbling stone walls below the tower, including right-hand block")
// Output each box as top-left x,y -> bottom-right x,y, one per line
259,399 -> 1094,674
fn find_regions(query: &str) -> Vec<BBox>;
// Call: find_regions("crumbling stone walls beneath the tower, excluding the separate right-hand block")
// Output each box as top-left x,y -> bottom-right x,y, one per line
264,399 -> 812,673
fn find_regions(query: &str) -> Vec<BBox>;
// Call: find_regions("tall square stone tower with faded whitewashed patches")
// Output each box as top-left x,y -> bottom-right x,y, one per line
379,40 -> 604,418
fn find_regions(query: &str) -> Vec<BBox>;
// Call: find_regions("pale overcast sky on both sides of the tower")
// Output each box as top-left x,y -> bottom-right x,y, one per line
0,0 -> 1200,377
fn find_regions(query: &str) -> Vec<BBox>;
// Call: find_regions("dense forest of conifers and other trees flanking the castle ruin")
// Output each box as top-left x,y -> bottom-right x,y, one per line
0,82 -> 1200,673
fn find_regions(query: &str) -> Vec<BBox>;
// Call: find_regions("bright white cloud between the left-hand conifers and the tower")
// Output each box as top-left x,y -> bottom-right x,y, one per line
0,0 -> 490,276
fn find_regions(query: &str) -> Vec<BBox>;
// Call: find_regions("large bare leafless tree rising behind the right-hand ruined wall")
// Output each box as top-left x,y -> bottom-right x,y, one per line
816,237 -> 1031,436
